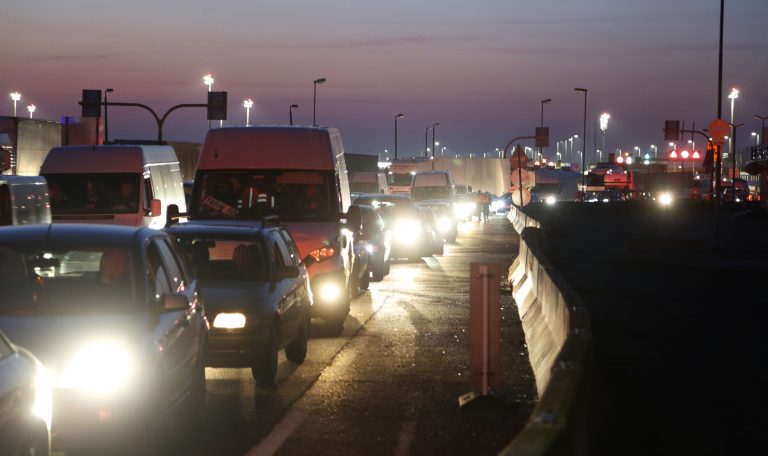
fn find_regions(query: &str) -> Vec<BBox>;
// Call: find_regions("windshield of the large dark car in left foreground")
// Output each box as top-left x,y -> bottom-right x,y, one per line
0,244 -> 137,313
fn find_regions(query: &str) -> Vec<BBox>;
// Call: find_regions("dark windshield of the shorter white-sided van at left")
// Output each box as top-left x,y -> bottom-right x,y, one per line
45,173 -> 143,215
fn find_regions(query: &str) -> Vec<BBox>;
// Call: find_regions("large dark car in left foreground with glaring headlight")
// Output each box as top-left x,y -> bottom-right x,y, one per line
0,224 -> 207,452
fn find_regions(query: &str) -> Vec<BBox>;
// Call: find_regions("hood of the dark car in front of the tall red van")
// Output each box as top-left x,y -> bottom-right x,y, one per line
200,280 -> 272,318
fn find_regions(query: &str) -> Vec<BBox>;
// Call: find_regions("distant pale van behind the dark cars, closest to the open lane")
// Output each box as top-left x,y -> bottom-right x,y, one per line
411,171 -> 458,242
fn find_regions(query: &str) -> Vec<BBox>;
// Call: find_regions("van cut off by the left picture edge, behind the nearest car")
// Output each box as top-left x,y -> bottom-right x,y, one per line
0,174 -> 51,226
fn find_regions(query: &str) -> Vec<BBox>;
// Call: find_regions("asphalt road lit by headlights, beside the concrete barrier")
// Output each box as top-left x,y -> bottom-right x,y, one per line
67,215 -> 536,456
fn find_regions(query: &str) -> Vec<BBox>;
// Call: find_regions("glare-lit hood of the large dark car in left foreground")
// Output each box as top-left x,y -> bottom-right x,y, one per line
0,314 -> 146,370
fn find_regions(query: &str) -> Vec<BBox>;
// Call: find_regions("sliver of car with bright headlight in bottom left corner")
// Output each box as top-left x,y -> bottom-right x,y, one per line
0,331 -> 51,455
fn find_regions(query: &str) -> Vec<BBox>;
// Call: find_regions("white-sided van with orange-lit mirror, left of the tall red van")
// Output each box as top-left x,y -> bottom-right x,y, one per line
40,145 -> 187,229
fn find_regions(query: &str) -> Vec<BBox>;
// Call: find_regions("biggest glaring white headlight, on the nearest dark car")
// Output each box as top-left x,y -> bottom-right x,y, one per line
58,341 -> 135,396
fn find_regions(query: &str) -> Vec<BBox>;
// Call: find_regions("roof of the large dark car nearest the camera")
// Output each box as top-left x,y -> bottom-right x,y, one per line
0,223 -> 154,247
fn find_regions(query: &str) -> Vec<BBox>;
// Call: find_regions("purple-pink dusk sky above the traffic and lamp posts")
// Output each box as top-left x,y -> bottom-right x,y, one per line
0,0 -> 768,162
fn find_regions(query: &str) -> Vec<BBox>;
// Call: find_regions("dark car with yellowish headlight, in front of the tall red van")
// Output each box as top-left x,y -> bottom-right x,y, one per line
165,217 -> 313,389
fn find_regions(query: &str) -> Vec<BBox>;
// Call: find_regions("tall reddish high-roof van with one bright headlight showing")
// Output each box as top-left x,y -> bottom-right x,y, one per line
189,126 -> 360,332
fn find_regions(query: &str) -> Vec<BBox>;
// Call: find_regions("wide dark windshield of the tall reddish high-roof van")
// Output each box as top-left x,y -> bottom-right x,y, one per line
191,170 -> 341,221
